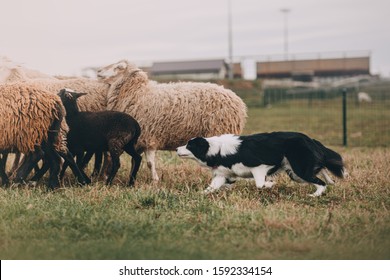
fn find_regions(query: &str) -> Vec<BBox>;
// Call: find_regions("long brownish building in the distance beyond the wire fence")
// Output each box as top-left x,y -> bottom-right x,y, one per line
256,56 -> 370,81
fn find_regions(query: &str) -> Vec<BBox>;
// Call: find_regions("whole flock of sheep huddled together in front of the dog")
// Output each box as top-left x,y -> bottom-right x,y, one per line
0,57 -> 247,189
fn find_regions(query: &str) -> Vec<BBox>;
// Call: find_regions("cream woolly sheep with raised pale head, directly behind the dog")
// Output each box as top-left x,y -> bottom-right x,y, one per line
98,60 -> 247,181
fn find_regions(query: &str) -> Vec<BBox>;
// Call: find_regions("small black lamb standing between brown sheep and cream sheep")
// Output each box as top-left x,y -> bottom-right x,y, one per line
58,89 -> 142,186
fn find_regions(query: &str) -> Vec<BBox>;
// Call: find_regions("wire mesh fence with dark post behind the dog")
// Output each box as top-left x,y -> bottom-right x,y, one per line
237,77 -> 390,147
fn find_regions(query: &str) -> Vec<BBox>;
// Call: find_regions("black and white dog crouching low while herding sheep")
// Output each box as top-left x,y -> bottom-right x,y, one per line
177,132 -> 344,196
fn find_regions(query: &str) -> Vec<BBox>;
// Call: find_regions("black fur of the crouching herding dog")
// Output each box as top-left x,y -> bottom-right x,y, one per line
180,132 -> 344,192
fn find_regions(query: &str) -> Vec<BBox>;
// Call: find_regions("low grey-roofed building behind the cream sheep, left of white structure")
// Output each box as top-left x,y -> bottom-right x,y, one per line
149,59 -> 228,80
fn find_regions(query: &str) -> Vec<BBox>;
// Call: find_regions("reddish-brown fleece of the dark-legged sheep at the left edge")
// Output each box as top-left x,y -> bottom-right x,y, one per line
0,83 -> 68,153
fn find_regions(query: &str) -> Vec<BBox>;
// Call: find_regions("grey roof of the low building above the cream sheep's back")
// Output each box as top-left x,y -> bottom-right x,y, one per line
151,59 -> 226,74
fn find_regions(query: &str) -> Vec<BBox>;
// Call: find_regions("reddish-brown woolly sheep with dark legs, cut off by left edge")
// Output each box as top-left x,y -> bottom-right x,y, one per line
0,84 -> 66,189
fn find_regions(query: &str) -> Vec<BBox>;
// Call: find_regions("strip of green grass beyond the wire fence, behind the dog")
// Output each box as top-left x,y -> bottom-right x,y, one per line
244,99 -> 390,147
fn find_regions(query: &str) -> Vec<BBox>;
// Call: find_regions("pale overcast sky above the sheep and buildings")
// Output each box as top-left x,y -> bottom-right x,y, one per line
0,0 -> 390,76
